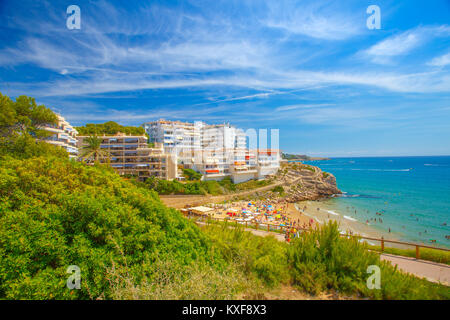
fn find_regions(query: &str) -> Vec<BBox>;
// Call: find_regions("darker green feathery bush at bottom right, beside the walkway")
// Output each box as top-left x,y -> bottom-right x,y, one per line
288,222 -> 450,299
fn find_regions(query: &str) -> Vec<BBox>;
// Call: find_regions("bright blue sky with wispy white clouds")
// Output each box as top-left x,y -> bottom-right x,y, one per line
0,0 -> 450,156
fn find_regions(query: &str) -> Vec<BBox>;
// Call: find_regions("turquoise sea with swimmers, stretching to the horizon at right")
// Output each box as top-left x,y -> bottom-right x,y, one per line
304,156 -> 450,247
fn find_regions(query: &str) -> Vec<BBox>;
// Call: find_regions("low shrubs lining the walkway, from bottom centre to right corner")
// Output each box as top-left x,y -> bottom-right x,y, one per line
204,223 -> 450,299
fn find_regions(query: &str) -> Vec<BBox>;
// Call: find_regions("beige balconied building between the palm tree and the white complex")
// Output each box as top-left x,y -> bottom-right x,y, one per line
77,133 -> 178,181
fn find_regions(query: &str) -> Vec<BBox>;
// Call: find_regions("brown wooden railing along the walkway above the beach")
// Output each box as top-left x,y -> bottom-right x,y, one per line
186,215 -> 450,259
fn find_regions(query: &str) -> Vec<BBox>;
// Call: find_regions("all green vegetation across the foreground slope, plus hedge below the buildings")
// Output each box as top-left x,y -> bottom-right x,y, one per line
0,95 -> 450,299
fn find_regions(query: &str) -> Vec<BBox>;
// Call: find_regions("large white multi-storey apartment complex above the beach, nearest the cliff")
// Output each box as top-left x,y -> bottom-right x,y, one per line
143,120 -> 279,183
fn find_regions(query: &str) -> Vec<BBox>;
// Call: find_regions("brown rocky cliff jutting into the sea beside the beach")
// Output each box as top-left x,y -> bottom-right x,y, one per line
277,162 -> 342,202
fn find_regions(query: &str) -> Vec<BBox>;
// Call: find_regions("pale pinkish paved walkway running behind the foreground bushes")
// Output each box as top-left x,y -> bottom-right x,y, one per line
197,221 -> 450,286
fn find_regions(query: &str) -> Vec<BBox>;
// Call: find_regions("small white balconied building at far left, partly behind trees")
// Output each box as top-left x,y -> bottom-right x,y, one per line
43,115 -> 78,158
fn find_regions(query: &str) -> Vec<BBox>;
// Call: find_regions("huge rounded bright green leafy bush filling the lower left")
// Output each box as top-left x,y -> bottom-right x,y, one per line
0,157 -> 219,299
